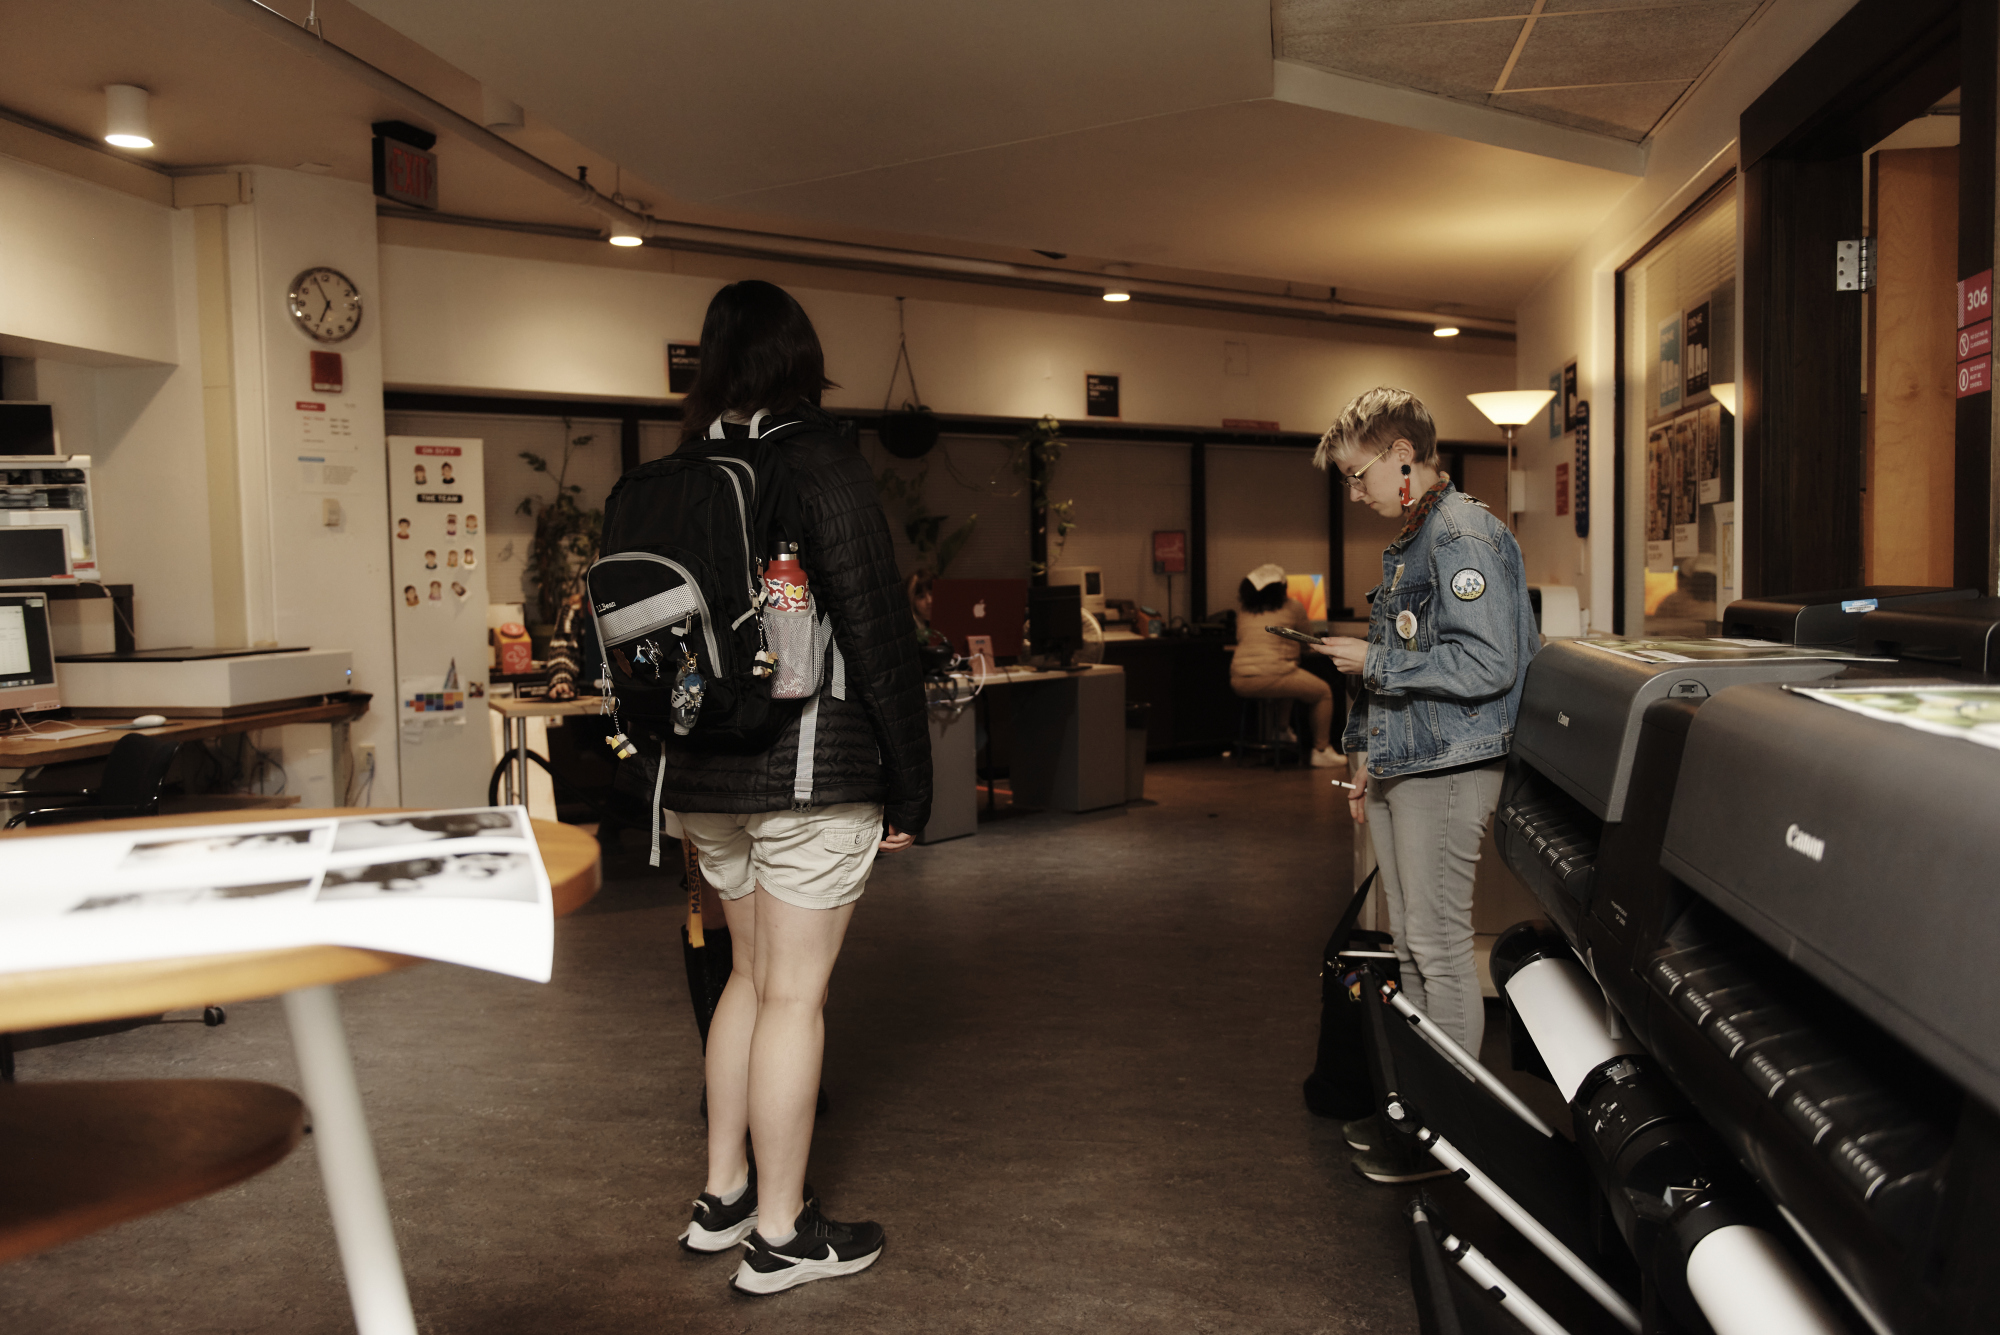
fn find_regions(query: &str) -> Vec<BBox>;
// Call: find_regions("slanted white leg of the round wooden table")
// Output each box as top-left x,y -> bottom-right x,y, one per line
284,987 -> 416,1335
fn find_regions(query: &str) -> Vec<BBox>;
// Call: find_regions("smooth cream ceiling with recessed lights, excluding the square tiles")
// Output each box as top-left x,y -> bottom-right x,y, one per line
0,0 -> 1750,316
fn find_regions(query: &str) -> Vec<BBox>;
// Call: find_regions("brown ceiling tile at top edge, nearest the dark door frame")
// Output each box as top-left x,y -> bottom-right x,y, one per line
1508,0 -> 1758,88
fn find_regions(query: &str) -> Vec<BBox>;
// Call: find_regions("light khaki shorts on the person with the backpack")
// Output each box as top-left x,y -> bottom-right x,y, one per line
678,801 -> 882,909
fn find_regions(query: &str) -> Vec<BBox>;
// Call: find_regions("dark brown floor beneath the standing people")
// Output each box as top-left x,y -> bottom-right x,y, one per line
0,761 -> 1440,1335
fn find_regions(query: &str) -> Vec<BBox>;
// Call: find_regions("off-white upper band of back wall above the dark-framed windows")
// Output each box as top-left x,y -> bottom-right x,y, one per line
382,244 -> 1514,440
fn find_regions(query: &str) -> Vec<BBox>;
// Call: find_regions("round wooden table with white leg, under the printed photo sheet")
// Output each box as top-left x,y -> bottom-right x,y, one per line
0,807 -> 602,1335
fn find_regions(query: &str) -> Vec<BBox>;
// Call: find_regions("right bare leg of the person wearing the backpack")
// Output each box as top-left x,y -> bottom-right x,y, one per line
744,887 -> 854,1239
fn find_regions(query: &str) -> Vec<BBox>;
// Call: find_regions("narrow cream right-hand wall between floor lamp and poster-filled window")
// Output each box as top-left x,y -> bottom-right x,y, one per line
1516,0 -> 1852,630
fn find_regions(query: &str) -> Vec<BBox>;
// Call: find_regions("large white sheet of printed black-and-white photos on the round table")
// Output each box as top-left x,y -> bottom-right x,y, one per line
0,807 -> 554,983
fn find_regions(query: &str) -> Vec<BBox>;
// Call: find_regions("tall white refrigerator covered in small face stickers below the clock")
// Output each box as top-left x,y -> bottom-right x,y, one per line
388,436 -> 494,807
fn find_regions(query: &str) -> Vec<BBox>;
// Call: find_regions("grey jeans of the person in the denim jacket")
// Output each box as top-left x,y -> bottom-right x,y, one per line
1368,761 -> 1506,1057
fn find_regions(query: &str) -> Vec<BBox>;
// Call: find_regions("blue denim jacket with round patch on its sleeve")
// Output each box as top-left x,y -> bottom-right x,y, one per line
1342,488 -> 1542,779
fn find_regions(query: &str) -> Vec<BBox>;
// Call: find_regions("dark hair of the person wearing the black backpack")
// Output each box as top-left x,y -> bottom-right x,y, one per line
680,278 -> 836,442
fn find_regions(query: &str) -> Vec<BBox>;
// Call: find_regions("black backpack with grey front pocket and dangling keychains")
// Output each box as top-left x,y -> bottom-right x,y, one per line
584,412 -> 824,753
